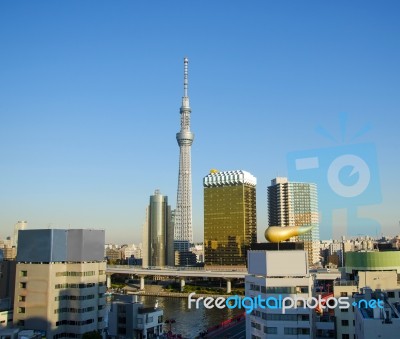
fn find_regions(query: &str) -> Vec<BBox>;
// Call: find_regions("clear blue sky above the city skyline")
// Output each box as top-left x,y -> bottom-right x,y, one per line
0,0 -> 400,243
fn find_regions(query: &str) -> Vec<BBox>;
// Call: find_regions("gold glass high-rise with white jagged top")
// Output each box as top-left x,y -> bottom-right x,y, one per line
203,170 -> 257,266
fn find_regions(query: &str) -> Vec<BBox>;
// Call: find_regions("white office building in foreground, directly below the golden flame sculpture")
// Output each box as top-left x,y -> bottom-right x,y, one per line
245,250 -> 314,339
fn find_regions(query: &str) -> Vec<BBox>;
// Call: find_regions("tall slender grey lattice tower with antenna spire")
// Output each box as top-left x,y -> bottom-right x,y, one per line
174,58 -> 194,243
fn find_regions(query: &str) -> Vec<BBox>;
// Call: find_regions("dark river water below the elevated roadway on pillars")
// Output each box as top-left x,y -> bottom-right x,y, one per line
138,296 -> 243,338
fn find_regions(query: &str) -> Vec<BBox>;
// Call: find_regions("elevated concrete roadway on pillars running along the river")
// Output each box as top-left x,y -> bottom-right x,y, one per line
106,265 -> 247,293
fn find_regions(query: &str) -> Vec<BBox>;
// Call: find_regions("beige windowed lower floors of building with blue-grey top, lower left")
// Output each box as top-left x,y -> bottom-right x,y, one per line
14,262 -> 106,338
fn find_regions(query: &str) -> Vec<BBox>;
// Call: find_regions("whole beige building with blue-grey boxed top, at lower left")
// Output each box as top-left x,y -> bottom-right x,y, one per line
14,229 -> 106,339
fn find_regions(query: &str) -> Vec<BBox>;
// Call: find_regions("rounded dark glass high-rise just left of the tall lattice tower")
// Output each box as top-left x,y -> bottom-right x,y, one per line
143,190 -> 175,267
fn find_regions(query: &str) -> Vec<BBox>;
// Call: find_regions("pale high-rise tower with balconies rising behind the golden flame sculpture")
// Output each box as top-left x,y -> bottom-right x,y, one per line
268,177 -> 320,266
